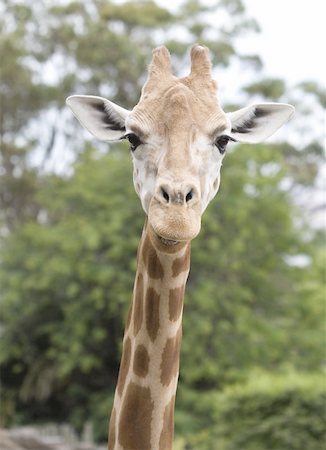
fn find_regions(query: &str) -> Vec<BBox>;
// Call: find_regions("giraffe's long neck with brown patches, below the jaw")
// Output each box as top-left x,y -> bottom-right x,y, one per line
109,223 -> 190,450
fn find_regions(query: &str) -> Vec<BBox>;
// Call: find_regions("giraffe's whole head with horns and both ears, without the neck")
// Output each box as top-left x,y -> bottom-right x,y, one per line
67,45 -> 294,246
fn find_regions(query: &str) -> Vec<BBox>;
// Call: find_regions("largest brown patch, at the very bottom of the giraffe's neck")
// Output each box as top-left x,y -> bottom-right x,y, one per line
119,383 -> 154,450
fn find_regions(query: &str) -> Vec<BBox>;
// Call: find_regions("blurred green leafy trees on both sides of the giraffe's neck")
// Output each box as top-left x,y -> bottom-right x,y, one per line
0,146 -> 324,438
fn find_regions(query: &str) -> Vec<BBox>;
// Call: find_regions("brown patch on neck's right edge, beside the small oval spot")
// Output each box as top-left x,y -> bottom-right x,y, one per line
161,327 -> 182,386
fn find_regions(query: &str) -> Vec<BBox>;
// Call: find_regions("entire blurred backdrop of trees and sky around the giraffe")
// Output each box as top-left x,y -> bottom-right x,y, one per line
0,0 -> 326,450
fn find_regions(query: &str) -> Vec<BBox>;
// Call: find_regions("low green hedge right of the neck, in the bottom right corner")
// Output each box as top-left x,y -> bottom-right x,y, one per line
176,370 -> 326,450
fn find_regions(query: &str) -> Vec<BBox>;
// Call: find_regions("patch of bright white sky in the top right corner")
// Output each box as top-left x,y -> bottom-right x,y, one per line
243,0 -> 326,85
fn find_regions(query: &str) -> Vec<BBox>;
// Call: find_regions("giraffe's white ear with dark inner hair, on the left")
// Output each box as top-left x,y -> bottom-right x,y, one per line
66,95 -> 129,141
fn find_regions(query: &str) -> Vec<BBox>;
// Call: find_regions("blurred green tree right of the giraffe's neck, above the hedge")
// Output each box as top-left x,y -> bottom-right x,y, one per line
182,145 -> 324,389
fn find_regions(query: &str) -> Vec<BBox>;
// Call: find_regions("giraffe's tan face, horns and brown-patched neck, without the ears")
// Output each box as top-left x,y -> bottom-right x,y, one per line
110,47 -> 227,450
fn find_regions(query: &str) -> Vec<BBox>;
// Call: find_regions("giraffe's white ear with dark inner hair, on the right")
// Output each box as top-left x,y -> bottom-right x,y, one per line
227,103 -> 294,144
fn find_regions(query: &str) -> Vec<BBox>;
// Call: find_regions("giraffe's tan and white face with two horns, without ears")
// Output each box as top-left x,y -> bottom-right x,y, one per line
126,46 -> 229,237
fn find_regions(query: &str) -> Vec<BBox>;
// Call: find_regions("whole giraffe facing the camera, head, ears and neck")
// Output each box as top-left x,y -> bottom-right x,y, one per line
67,45 -> 294,450
